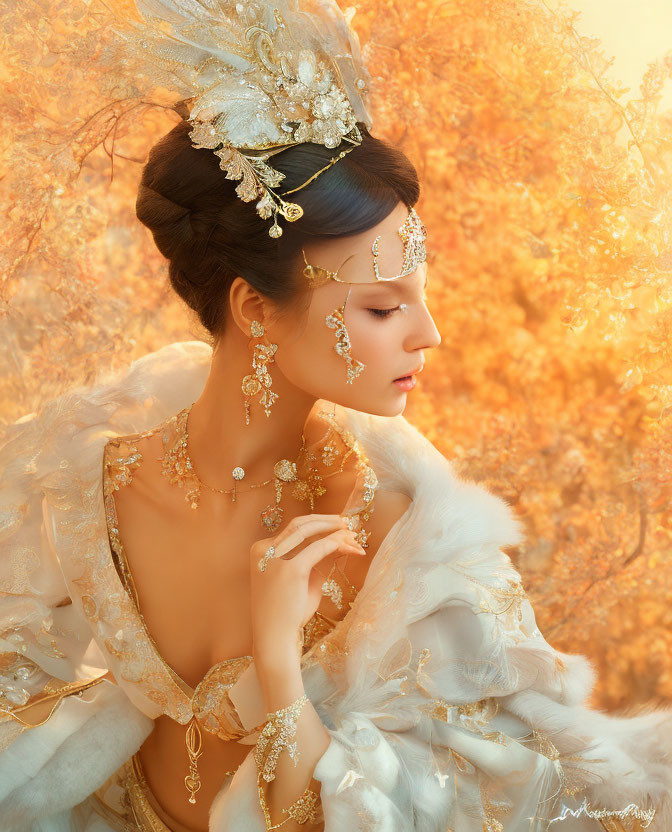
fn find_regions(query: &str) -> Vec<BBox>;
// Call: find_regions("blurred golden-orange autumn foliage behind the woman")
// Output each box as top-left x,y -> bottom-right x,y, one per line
0,0 -> 672,709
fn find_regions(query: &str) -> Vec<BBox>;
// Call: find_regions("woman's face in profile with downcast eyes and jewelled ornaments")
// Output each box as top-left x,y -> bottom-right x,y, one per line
268,202 -> 441,416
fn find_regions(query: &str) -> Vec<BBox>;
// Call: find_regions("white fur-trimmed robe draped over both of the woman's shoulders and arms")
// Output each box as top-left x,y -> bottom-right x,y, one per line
0,341 -> 672,832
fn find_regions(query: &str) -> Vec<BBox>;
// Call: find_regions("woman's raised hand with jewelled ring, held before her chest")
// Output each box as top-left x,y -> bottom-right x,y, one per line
250,514 -> 366,662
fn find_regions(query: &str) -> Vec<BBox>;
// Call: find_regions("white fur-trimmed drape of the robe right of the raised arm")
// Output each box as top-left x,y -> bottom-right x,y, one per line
212,372 -> 672,832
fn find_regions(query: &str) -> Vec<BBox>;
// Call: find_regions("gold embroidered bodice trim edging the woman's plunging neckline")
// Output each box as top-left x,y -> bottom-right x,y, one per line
103,408 -> 377,740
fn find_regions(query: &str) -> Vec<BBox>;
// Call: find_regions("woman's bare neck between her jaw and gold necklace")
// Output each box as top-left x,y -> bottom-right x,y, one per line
188,333 -> 318,489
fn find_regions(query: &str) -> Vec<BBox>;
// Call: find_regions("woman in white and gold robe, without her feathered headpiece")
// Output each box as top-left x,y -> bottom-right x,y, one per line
0,1 -> 672,832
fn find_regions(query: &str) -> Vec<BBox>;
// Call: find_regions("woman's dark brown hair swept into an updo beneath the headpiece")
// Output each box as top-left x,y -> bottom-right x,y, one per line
136,120 -> 419,338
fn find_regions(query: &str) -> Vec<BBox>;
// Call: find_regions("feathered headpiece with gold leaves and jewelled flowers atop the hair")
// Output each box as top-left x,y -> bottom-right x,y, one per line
114,0 -> 372,238
